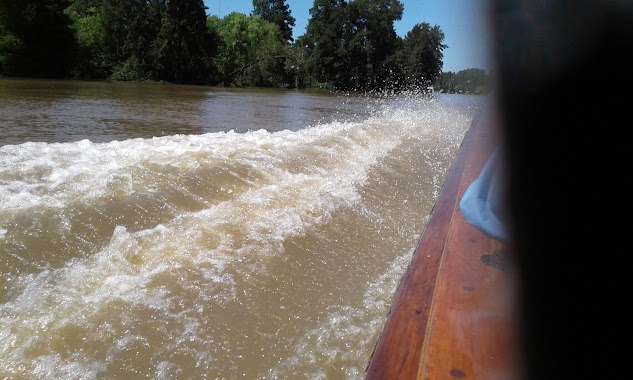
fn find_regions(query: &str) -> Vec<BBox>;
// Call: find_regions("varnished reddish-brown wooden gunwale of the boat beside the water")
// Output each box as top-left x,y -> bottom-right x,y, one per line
365,111 -> 517,380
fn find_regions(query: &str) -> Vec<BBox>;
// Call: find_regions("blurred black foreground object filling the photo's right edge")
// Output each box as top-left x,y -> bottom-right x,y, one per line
491,0 -> 633,380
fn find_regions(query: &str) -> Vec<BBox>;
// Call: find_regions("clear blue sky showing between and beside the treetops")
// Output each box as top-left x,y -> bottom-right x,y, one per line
204,0 -> 491,72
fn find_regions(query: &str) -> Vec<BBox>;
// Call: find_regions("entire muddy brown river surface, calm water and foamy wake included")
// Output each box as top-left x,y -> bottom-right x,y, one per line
0,79 -> 485,379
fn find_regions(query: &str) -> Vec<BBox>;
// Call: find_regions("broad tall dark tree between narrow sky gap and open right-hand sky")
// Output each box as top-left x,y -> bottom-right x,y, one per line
306,0 -> 404,91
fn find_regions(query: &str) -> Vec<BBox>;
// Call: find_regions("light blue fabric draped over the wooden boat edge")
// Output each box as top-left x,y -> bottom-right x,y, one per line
459,148 -> 507,243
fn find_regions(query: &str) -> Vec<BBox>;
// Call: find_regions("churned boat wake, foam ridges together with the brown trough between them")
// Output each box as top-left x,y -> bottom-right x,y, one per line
0,94 -> 470,377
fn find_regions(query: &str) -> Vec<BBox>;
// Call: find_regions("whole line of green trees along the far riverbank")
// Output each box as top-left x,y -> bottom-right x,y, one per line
0,0 -> 487,93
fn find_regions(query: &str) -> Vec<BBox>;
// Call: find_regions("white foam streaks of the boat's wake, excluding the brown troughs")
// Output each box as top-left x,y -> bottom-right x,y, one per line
0,95 -> 476,378
